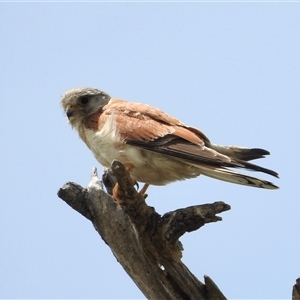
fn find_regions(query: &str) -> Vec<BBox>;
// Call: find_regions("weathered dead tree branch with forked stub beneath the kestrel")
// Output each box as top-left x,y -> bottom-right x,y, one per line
58,161 -> 230,300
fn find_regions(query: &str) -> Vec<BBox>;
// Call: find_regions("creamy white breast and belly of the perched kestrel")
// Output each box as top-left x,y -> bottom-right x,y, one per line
84,120 -> 200,185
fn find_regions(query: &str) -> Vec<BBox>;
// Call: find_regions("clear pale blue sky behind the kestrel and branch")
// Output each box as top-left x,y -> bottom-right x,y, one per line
0,3 -> 300,299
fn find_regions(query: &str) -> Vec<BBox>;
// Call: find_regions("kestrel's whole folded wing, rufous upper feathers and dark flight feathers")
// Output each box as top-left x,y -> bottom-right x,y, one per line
85,99 -> 277,176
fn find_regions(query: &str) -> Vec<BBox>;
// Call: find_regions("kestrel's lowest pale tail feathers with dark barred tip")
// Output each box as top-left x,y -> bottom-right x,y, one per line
199,165 -> 278,189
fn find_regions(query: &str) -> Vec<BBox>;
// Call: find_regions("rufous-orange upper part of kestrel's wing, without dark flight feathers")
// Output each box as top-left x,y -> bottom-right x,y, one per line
85,99 -> 209,146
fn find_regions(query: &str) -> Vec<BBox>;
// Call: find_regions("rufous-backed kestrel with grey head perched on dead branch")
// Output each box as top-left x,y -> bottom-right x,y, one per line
61,87 -> 279,195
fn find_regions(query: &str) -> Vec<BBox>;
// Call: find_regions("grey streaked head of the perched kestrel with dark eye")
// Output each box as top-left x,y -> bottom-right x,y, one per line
60,88 -> 111,128
